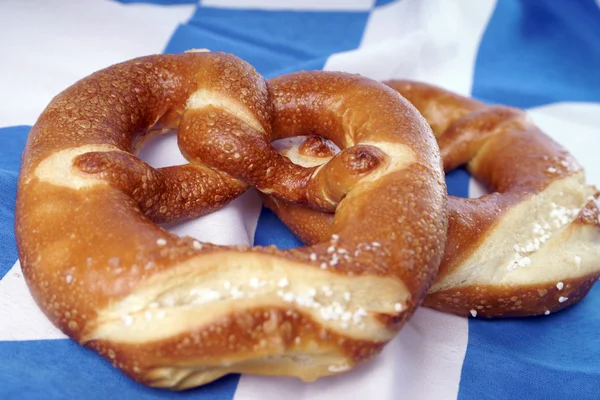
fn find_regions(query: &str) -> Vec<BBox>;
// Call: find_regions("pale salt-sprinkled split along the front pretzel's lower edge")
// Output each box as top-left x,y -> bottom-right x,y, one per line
85,254 -> 408,343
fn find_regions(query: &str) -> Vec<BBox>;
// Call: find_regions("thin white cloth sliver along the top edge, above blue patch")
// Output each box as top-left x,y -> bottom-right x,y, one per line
200,0 -> 375,11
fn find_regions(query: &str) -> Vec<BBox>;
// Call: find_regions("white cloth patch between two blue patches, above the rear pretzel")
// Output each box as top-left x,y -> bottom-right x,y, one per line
325,0 -> 495,95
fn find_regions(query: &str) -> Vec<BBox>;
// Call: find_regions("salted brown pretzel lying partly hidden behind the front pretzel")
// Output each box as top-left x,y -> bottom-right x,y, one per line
265,80 -> 600,318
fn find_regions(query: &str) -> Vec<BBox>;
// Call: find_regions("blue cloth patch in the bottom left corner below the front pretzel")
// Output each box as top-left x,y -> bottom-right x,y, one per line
0,340 -> 237,400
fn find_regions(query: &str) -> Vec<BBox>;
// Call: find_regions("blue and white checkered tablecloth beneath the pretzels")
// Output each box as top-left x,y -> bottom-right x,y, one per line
0,0 -> 600,400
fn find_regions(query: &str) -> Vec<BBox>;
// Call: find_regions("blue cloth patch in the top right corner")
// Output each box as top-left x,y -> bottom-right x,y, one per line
473,0 -> 600,108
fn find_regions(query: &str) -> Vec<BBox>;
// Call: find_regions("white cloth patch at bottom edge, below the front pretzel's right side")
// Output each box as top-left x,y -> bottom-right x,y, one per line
234,308 -> 467,400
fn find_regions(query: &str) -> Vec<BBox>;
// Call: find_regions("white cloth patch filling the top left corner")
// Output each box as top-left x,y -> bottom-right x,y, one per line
0,0 -> 194,126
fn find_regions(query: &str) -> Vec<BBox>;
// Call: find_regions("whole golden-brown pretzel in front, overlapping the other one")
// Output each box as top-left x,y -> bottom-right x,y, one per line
15,52 -> 447,390
